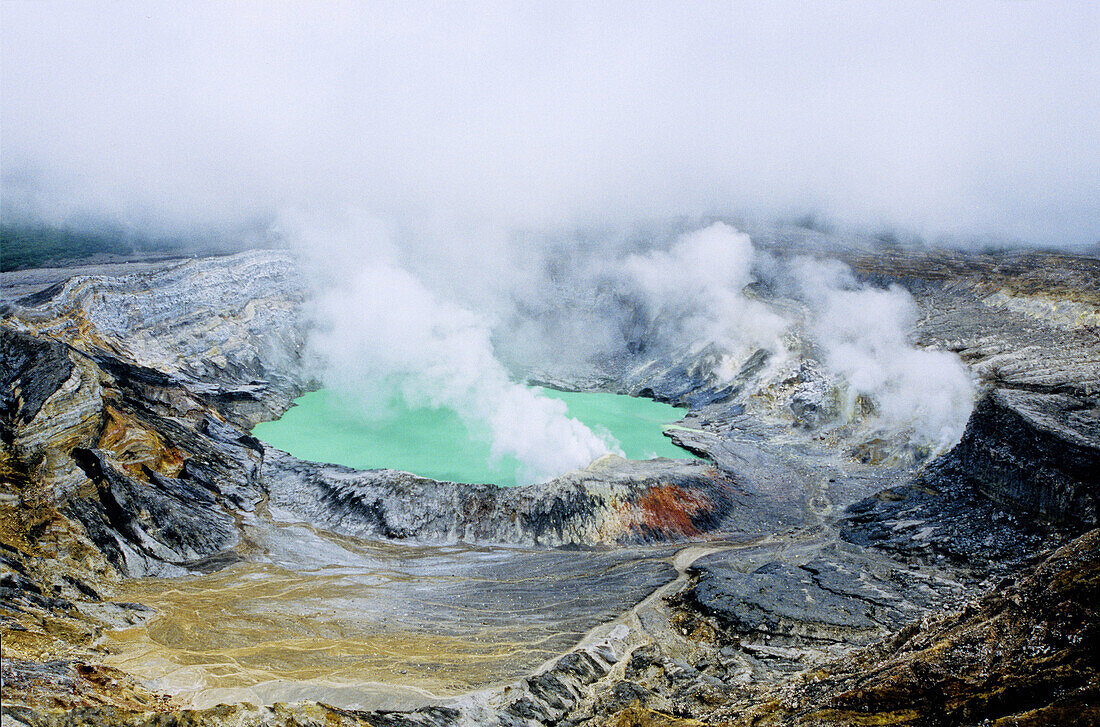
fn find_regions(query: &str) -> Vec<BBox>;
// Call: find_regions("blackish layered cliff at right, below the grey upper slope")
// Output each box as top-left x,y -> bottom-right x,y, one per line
840,382 -> 1100,572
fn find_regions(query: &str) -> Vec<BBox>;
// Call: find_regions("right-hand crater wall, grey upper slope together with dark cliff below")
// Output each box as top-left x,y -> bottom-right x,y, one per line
827,239 -> 1100,571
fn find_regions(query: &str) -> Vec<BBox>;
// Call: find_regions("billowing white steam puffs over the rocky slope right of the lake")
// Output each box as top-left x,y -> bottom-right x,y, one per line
623,222 -> 975,449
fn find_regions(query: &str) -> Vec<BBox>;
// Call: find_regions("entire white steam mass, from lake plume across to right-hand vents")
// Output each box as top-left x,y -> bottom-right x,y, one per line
292,212 -> 974,482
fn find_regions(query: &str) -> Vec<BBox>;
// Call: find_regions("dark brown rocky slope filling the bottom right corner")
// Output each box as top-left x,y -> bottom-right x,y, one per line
711,530 -> 1100,726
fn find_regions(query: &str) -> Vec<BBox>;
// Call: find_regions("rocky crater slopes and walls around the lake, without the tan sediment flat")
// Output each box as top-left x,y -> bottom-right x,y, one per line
0,239 -> 1100,725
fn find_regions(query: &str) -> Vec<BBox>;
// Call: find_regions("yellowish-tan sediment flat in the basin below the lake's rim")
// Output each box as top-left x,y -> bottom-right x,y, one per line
105,552 -> 602,708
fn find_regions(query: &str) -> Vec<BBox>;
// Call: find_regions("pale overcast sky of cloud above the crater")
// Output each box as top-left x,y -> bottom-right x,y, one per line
0,0 -> 1100,244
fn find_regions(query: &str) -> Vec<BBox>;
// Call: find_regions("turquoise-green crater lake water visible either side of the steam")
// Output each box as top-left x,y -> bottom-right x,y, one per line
252,389 -> 693,486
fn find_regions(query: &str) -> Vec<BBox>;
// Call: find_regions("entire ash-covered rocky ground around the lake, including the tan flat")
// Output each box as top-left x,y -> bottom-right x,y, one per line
0,228 -> 1100,725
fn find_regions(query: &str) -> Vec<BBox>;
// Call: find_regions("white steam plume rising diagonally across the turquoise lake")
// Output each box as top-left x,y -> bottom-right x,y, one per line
282,214 -> 622,483
